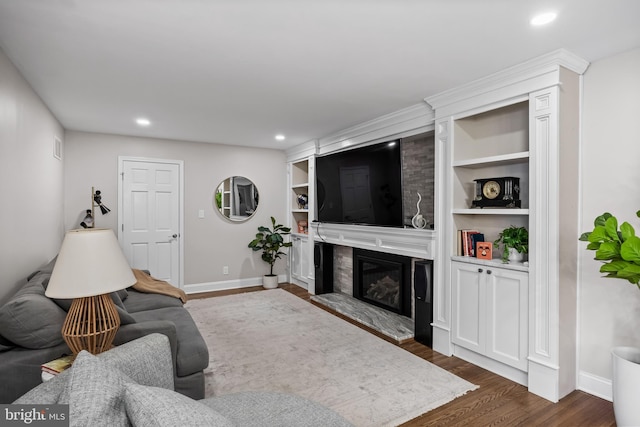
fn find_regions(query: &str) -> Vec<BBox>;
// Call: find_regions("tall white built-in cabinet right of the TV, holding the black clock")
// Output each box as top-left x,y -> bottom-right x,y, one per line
426,50 -> 588,402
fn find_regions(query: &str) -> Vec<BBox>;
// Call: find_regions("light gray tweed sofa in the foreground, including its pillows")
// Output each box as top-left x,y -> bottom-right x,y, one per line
15,334 -> 351,427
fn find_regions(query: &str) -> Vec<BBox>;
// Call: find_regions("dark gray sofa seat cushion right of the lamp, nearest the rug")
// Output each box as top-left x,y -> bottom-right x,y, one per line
129,310 -> 209,377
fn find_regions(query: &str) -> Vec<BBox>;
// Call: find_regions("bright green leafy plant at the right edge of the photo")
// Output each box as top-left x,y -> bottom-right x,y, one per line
580,211 -> 640,288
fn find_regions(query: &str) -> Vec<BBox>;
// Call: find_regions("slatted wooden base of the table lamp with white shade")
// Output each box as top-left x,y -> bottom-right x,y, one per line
62,294 -> 120,355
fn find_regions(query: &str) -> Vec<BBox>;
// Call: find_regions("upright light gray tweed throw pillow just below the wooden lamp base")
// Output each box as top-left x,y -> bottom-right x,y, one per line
59,350 -> 133,426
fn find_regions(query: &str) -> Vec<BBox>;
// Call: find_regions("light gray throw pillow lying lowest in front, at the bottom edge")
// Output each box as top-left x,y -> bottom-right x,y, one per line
125,383 -> 233,427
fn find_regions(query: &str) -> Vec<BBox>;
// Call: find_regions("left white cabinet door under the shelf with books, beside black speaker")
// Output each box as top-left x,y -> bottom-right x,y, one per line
451,262 -> 485,353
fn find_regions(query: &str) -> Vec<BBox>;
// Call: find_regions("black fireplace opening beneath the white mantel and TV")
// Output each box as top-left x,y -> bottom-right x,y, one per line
353,248 -> 411,318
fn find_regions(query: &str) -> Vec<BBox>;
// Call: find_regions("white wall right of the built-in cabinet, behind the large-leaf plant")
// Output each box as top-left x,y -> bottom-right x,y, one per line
578,48 -> 640,388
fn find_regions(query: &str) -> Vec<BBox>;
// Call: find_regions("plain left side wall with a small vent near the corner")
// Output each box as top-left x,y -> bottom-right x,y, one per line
0,50 -> 64,304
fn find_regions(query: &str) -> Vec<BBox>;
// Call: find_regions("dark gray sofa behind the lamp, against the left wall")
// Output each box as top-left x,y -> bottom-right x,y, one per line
0,260 -> 209,403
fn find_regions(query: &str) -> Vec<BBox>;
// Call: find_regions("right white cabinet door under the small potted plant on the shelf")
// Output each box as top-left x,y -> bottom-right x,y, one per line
485,268 -> 529,371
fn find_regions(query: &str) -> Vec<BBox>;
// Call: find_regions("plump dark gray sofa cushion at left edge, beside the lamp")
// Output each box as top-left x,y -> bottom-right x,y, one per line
0,282 -> 67,349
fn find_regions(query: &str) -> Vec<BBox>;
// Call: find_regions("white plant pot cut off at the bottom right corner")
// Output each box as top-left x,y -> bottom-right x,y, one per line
611,347 -> 640,426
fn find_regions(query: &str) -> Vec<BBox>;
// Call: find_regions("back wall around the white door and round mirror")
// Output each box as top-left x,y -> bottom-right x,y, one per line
64,131 -> 287,285
